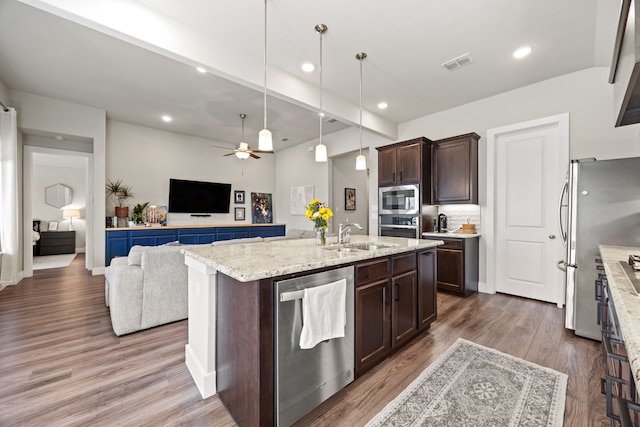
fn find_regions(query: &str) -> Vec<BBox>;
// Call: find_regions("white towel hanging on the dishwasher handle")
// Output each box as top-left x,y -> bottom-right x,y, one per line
300,279 -> 347,349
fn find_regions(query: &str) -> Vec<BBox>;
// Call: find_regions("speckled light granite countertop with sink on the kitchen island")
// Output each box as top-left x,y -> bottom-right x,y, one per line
182,235 -> 444,282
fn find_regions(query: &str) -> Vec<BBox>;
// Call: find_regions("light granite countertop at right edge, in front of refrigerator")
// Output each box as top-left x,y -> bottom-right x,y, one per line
600,245 -> 640,384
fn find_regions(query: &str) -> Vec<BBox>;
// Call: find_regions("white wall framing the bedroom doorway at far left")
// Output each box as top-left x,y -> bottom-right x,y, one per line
10,91 -> 106,274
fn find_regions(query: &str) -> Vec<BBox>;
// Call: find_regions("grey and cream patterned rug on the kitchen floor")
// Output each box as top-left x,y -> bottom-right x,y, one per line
367,338 -> 567,427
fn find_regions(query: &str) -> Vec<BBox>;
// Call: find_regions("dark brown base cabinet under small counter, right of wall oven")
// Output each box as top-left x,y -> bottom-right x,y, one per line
437,237 -> 479,296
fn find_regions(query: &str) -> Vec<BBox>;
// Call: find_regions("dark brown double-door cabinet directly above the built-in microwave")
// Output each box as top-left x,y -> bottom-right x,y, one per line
377,137 -> 431,187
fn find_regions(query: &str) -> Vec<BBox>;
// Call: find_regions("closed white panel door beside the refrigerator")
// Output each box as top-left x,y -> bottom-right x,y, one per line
494,124 -> 568,306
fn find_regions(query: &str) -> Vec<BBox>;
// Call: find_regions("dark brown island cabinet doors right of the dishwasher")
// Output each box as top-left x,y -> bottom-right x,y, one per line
355,249 -> 436,377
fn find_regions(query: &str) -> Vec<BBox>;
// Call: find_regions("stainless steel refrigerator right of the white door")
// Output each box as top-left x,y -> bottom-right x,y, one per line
559,157 -> 640,340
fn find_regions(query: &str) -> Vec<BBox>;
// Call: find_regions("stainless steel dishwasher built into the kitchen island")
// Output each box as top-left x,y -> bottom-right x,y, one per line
275,266 -> 355,426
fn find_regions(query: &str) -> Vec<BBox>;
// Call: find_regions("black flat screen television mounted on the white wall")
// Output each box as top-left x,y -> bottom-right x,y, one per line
169,178 -> 231,214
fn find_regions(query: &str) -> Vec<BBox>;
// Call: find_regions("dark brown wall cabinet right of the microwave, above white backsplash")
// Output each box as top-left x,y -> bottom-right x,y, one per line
432,133 -> 480,205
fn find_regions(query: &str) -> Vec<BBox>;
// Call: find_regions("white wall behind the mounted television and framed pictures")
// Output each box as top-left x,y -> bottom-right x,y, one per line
103,120 -> 276,225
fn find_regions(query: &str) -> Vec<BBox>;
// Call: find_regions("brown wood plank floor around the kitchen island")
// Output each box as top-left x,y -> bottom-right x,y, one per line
0,256 -> 610,427
